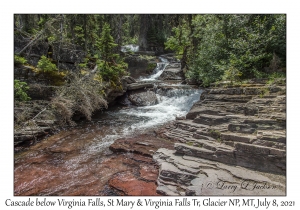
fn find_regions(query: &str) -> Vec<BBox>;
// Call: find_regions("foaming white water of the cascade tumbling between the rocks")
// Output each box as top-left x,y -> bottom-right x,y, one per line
95,57 -> 202,139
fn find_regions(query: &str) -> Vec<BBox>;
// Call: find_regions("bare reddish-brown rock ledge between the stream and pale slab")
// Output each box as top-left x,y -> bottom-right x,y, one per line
106,134 -> 174,196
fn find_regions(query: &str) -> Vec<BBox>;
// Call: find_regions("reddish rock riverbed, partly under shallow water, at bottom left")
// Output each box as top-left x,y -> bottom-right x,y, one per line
14,124 -> 173,196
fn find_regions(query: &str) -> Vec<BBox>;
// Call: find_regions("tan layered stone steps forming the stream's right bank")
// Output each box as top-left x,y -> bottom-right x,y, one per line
153,79 -> 286,195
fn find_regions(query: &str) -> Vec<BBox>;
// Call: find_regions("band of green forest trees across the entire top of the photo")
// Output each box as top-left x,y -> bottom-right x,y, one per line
14,14 -> 286,86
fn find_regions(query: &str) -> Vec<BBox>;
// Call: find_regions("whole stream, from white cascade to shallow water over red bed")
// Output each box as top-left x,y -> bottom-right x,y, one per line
14,55 -> 201,195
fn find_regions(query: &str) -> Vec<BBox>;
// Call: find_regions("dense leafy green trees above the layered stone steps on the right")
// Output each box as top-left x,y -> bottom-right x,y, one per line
170,15 -> 286,86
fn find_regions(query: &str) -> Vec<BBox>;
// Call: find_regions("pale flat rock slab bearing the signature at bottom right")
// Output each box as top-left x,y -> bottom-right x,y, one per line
153,148 -> 285,196
